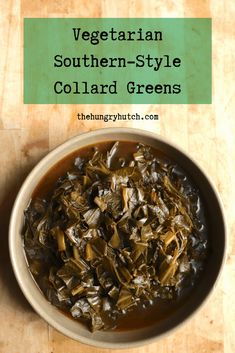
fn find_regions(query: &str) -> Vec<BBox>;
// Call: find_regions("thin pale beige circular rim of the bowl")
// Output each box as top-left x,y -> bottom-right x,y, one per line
8,127 -> 227,349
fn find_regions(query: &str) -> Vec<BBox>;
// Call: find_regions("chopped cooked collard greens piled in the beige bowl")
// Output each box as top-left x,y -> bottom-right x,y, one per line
23,142 -> 207,331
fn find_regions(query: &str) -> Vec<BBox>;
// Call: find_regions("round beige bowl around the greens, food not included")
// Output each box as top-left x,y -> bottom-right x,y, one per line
9,128 -> 226,348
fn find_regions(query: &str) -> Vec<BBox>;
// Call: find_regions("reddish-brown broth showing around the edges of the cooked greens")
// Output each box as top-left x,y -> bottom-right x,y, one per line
28,141 -> 208,330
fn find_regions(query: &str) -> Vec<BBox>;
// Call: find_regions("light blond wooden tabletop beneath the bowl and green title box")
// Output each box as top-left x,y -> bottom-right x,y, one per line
0,0 -> 235,353
